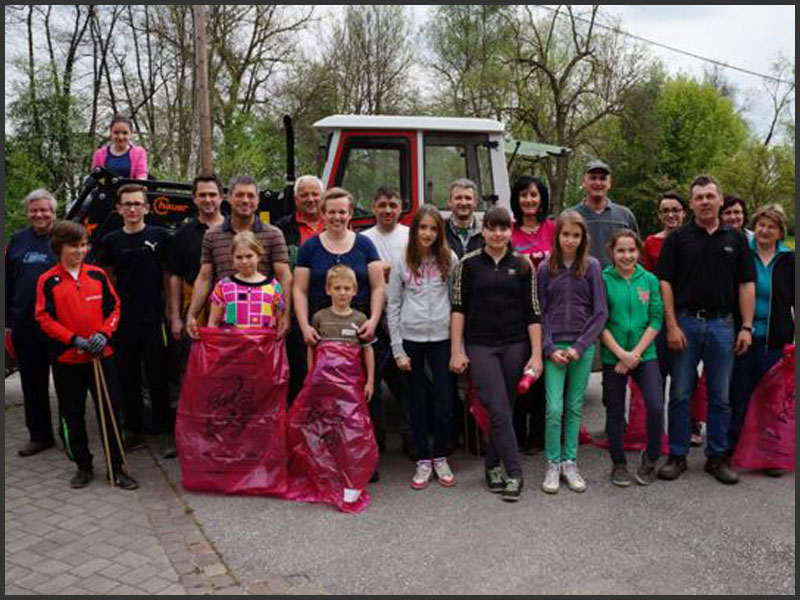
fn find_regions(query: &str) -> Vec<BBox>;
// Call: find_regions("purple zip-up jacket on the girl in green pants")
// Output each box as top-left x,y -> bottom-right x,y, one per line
537,256 -> 608,357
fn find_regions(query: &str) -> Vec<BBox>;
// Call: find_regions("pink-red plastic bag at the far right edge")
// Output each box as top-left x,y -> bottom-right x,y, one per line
732,344 -> 794,471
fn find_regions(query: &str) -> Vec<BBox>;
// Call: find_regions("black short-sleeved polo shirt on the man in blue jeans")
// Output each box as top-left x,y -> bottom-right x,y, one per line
656,219 -> 755,312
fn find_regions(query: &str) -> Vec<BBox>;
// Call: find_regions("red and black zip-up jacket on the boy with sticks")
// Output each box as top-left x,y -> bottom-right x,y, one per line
36,263 -> 119,364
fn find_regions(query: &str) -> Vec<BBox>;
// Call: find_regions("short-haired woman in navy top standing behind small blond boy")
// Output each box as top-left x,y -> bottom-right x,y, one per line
292,188 -> 384,346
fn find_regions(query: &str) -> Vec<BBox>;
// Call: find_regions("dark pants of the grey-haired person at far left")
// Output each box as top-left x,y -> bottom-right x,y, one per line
11,319 -> 53,443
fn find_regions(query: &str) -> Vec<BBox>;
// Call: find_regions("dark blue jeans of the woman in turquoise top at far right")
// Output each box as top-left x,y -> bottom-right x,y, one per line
728,337 -> 782,450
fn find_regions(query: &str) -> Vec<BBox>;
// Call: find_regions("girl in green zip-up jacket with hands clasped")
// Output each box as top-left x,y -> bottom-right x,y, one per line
600,229 -> 664,487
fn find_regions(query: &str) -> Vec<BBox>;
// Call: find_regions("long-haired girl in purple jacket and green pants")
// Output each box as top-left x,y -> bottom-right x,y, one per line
538,210 -> 608,494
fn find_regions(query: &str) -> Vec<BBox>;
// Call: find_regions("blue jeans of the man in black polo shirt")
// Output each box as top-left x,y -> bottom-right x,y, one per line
669,312 -> 735,457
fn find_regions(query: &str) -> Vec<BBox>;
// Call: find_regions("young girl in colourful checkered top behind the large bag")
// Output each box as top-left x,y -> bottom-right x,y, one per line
208,230 -> 286,329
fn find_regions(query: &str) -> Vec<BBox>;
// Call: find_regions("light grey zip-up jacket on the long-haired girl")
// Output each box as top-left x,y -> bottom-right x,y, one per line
386,252 -> 458,358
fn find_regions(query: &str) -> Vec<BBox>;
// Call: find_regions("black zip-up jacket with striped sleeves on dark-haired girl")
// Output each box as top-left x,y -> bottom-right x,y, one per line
452,248 -> 542,346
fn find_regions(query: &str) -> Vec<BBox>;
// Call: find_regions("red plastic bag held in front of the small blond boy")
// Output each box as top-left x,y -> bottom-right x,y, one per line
285,342 -> 378,512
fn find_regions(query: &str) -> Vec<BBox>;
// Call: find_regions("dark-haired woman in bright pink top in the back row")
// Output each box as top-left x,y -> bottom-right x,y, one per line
511,175 -> 556,454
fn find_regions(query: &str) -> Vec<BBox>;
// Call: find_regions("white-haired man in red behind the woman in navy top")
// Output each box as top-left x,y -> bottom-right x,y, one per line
275,175 -> 325,403
